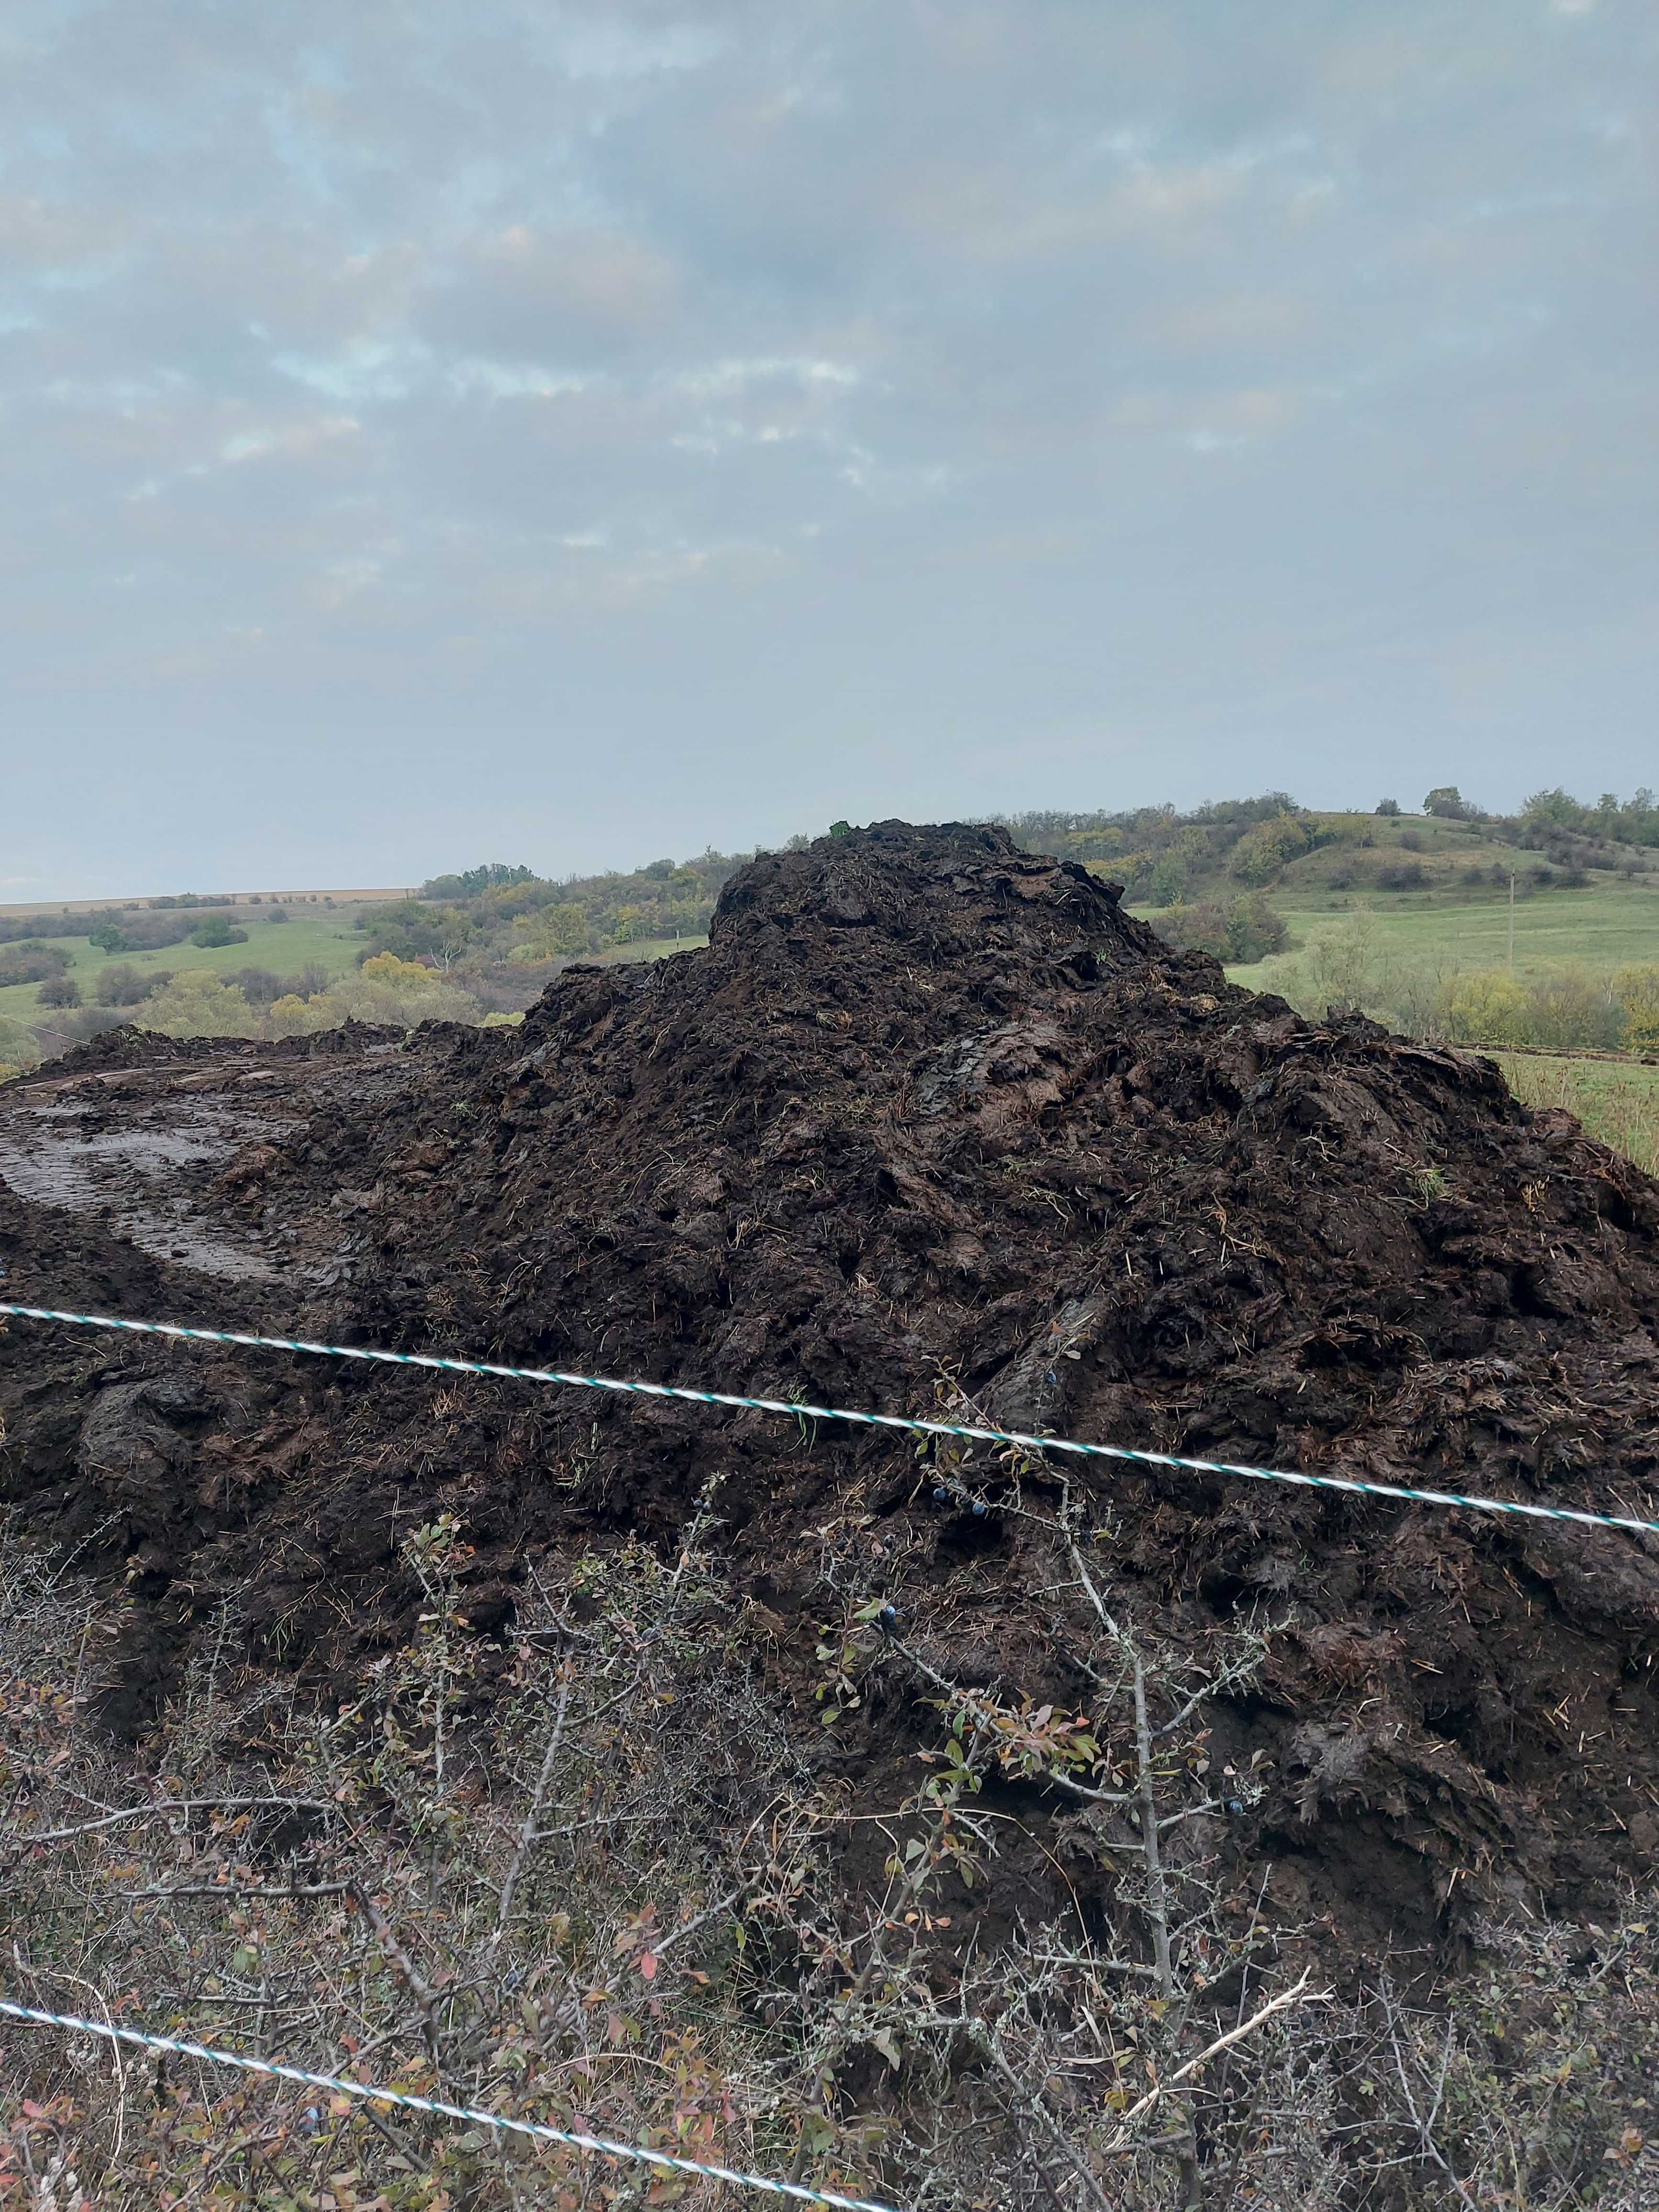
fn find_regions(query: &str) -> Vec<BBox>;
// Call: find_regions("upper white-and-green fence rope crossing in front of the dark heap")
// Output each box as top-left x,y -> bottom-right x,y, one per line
0,1303 -> 1659,1535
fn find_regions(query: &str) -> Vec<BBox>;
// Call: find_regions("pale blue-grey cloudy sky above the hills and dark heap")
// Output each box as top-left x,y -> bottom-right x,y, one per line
0,0 -> 1659,900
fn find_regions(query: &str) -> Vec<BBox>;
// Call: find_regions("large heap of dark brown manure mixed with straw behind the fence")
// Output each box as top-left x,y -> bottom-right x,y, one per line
0,823 -> 1659,1942
